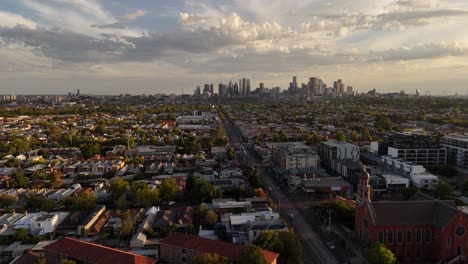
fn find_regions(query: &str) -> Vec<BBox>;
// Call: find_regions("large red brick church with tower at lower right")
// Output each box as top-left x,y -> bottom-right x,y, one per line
355,168 -> 468,263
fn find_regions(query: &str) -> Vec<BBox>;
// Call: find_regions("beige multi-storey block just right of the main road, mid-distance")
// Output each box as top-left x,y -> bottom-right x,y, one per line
271,142 -> 319,170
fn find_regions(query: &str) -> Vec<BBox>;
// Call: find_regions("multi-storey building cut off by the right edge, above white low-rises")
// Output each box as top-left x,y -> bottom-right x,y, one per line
441,135 -> 468,169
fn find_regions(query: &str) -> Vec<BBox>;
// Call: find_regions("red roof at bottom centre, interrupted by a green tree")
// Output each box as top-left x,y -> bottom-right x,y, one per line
160,233 -> 279,263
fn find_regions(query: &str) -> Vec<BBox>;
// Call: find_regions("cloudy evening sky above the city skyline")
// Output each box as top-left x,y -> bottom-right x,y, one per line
0,0 -> 468,95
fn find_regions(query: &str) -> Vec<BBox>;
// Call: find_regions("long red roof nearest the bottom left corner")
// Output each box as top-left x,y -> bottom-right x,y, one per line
44,237 -> 156,264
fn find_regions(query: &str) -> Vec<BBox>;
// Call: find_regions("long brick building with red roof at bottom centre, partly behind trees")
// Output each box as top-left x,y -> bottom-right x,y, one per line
159,233 -> 279,264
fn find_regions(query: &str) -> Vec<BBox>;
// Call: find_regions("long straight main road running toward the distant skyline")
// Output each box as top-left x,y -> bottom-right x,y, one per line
223,120 -> 338,264
